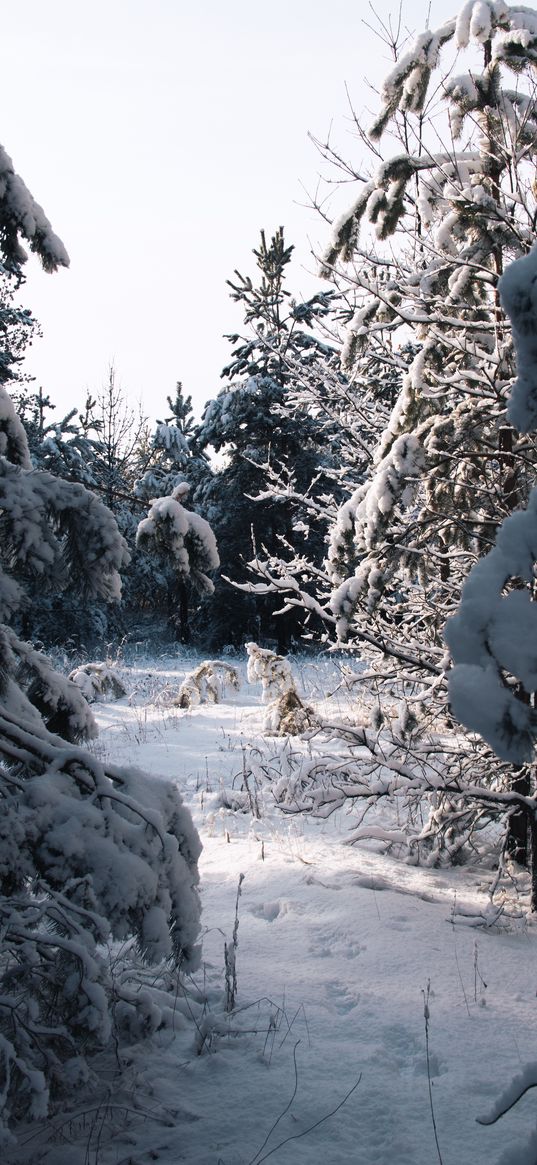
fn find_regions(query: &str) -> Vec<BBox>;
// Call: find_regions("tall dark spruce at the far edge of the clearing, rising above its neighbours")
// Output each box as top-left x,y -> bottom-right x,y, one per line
196,227 -> 334,650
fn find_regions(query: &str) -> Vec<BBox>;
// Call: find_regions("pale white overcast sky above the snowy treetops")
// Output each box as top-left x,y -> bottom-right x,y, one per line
0,0 -> 459,426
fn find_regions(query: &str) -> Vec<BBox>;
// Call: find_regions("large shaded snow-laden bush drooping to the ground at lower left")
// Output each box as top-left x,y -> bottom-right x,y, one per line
0,745 -> 200,1144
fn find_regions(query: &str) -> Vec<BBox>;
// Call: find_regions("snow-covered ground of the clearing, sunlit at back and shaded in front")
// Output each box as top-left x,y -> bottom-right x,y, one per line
12,658 -> 537,1165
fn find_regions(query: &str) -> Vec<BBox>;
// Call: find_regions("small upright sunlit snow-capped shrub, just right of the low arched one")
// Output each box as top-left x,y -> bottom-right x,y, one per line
246,643 -> 318,736
